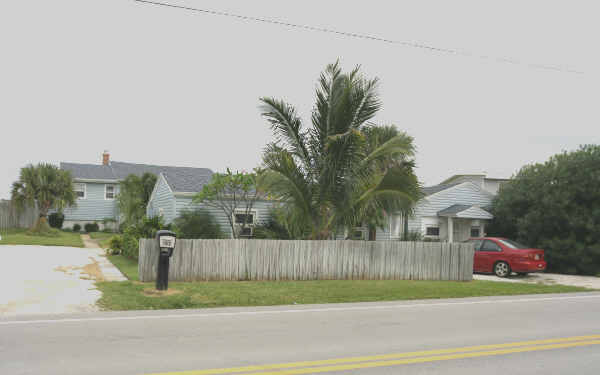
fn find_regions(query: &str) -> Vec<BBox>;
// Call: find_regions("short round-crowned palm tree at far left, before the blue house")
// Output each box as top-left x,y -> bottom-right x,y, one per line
11,163 -> 76,233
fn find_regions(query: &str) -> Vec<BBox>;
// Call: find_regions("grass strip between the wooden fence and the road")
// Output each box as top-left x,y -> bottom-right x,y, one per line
97,256 -> 589,310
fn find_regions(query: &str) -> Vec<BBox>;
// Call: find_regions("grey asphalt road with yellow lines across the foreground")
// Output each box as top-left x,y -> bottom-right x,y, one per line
0,293 -> 600,375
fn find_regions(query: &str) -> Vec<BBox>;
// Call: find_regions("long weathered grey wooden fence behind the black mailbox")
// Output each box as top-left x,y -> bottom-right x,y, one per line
138,239 -> 474,281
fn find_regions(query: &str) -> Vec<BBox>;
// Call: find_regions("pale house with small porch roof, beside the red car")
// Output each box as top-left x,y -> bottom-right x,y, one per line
366,180 -> 498,242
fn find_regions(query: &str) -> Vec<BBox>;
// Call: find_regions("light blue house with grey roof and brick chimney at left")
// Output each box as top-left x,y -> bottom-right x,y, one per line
60,151 -> 271,235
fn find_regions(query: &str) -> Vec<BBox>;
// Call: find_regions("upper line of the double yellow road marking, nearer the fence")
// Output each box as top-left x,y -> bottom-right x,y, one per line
152,335 -> 600,375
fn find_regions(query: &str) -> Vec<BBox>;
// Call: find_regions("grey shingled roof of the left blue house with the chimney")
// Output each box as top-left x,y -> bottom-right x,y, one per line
60,161 -> 213,193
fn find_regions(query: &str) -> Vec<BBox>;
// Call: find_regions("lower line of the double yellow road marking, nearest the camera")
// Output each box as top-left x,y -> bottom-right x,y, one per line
246,340 -> 600,375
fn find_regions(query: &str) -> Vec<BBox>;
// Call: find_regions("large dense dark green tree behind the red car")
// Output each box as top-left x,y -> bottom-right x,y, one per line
487,145 -> 600,275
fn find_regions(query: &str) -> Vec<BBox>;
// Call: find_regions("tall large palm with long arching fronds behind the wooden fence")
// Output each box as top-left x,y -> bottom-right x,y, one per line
259,63 -> 419,239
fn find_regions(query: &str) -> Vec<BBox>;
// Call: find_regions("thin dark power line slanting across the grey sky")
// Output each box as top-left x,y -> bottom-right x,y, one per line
133,0 -> 584,74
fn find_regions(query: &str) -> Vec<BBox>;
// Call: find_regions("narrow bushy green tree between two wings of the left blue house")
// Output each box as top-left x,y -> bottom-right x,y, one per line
117,173 -> 157,225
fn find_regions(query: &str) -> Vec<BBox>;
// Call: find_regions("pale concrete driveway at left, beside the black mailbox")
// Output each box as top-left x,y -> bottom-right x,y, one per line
0,245 -> 125,316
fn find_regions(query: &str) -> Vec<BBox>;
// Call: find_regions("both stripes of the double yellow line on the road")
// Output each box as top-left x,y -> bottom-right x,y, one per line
153,335 -> 600,375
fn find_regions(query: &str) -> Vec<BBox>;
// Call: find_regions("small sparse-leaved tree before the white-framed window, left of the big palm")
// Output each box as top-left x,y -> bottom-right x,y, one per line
193,168 -> 265,238
